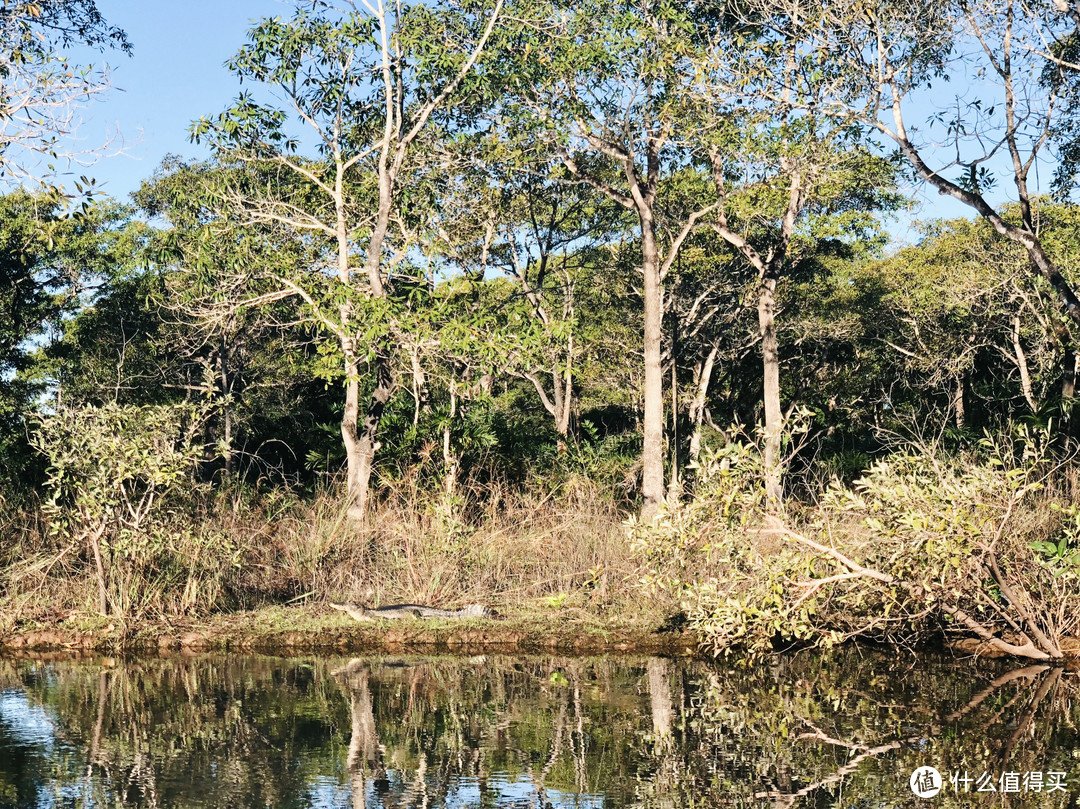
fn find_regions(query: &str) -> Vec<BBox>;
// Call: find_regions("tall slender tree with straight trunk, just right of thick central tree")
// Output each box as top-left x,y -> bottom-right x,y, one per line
656,4 -> 897,505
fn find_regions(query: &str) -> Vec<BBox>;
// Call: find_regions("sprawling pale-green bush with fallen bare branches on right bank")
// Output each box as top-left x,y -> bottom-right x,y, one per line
633,430 -> 1080,659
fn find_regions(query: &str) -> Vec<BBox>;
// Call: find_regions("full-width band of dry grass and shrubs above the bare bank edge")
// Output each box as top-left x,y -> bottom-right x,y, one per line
8,403 -> 1080,660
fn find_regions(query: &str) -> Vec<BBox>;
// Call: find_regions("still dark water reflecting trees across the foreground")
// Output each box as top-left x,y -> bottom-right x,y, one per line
0,649 -> 1080,809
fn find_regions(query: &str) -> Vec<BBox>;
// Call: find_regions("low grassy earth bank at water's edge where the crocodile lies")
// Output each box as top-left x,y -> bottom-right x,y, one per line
0,605 -> 698,656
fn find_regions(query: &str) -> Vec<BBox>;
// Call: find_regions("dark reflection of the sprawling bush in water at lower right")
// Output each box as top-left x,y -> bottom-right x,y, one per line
678,661 -> 1071,807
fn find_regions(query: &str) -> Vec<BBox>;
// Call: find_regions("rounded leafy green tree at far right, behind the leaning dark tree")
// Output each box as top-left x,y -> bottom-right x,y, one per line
853,206 -> 1080,431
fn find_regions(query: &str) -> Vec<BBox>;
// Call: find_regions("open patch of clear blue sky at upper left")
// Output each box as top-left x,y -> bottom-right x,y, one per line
77,0 -> 293,200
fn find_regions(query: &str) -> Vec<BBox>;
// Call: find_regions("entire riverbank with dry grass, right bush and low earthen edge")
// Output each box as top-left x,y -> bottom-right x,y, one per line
12,442 -> 1080,663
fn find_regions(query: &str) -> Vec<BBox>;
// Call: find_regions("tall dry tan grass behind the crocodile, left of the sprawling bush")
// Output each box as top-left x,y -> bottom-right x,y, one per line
0,466 -> 637,631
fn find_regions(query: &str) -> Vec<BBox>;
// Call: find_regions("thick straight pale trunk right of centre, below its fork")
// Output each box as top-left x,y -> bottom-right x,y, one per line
638,216 -> 664,520
